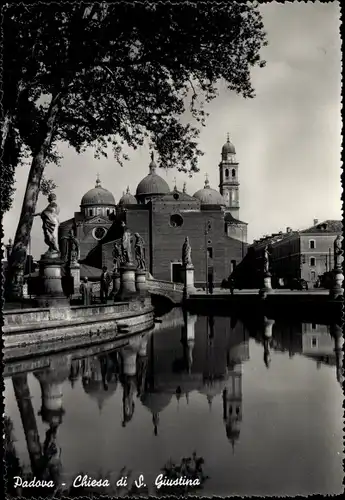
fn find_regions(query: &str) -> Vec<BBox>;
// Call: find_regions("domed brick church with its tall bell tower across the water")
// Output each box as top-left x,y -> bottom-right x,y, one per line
59,136 -> 247,286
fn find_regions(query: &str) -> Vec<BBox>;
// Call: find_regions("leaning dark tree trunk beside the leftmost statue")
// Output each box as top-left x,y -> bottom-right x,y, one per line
6,93 -> 61,301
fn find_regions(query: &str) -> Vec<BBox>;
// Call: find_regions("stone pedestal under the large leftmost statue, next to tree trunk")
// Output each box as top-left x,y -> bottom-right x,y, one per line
37,253 -> 69,307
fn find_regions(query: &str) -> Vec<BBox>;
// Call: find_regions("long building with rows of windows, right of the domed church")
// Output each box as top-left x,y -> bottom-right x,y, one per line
242,219 -> 343,287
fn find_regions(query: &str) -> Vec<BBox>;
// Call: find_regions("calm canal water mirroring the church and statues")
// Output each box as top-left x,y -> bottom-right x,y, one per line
5,309 -> 343,496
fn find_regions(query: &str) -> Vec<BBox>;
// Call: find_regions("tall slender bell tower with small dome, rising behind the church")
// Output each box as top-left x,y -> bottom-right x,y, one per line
219,134 -> 240,219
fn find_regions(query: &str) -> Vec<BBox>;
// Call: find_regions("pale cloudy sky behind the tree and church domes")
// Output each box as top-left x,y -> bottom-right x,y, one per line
4,2 -> 341,258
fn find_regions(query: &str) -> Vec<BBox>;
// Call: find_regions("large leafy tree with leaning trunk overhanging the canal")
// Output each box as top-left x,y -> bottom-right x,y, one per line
3,2 -> 266,295
